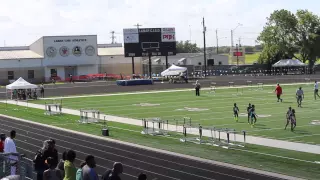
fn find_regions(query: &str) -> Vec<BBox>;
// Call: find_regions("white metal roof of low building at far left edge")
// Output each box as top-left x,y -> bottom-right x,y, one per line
0,50 -> 43,60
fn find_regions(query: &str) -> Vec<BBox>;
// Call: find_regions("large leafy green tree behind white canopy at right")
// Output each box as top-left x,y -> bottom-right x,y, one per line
258,9 -> 320,71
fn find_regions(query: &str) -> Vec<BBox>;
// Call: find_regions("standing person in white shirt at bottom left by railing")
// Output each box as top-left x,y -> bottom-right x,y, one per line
4,130 -> 18,175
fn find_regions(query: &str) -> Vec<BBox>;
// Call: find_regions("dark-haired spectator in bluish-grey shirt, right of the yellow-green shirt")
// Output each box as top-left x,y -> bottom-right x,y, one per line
82,155 -> 99,180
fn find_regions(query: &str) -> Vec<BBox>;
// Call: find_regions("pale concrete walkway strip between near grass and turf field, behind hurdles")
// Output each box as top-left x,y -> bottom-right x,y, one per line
0,100 -> 320,154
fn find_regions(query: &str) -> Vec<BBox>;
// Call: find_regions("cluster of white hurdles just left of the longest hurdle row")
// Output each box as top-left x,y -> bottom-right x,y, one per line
141,118 -> 169,136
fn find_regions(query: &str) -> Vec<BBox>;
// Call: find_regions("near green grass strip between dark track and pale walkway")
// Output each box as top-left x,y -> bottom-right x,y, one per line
0,103 -> 320,179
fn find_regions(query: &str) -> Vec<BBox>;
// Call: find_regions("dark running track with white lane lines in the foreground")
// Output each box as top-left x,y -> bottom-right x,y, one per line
0,117 -> 290,180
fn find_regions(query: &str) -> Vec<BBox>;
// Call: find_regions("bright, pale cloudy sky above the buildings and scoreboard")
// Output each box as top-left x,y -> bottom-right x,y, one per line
0,0 -> 320,47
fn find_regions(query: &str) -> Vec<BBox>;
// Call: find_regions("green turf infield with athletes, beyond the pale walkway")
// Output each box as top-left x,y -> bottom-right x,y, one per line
37,85 -> 320,144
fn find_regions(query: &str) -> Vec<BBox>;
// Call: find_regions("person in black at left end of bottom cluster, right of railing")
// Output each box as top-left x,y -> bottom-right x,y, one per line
33,140 -> 49,180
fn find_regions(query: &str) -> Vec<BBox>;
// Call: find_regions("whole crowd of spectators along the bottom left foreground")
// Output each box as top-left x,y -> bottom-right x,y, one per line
0,130 -> 147,180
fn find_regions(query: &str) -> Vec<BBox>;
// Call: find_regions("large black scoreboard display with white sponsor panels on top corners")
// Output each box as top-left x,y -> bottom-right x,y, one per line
123,28 -> 177,57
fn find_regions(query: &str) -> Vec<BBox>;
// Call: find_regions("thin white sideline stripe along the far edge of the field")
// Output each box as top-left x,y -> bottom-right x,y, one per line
42,83 -> 313,100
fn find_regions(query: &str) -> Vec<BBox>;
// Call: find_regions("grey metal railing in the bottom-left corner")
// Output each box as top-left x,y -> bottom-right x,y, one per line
0,153 -> 33,180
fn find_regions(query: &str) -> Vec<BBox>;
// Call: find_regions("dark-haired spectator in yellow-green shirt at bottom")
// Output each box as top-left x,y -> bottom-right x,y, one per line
63,150 -> 77,180
